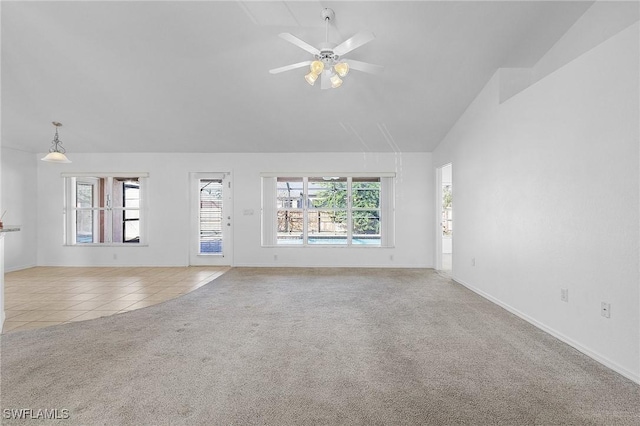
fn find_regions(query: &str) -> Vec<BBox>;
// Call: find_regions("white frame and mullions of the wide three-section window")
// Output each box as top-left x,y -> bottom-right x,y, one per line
260,172 -> 395,249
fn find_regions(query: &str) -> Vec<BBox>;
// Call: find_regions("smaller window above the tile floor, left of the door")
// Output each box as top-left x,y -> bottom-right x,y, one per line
63,174 -> 146,245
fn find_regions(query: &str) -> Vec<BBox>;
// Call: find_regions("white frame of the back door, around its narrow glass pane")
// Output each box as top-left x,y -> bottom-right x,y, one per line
188,172 -> 233,266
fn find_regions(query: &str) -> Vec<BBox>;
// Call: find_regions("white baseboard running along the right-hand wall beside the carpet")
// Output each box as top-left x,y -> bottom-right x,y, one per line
452,277 -> 640,384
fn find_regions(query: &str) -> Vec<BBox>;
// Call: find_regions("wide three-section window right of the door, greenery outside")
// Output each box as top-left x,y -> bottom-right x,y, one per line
262,175 -> 394,247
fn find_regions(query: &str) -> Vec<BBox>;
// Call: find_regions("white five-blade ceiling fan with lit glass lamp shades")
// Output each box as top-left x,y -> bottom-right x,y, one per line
269,8 -> 384,89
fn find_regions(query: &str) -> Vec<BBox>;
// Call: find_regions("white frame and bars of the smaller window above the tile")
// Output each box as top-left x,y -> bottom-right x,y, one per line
61,172 -> 149,247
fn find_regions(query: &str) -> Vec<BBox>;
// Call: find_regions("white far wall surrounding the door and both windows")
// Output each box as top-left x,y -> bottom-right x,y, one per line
37,153 -> 435,267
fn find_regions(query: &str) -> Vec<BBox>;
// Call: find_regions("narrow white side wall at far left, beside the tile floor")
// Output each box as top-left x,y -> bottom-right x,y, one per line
2,147 -> 38,272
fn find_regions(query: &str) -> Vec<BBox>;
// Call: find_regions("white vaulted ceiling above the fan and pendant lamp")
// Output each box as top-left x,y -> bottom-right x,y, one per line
1,1 -> 592,153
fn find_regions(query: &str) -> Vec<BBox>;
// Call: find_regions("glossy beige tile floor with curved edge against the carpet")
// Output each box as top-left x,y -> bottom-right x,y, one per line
2,266 -> 229,333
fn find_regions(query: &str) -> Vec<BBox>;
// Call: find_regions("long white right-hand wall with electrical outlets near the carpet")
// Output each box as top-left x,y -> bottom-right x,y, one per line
433,23 -> 640,382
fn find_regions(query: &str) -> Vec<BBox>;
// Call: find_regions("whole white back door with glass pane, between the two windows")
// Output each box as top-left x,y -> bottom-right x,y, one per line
189,173 -> 233,266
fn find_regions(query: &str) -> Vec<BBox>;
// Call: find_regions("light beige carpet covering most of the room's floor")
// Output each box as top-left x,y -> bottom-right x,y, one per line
0,268 -> 640,425
